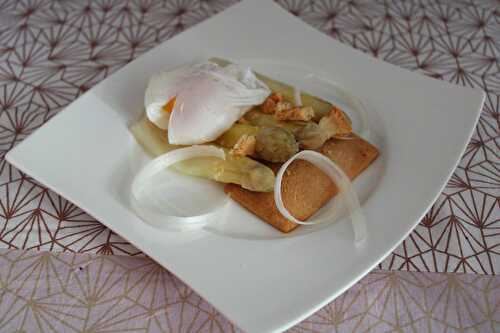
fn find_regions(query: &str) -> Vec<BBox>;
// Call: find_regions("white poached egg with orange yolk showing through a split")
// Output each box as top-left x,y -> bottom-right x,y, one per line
144,62 -> 271,145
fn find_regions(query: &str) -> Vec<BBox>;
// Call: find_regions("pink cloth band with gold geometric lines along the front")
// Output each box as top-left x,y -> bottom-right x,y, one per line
0,250 -> 500,333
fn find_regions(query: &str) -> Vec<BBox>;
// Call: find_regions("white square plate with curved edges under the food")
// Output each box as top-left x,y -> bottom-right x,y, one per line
7,0 -> 484,332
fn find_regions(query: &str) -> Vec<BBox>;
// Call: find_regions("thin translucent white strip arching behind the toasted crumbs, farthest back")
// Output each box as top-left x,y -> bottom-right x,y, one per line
305,74 -> 371,141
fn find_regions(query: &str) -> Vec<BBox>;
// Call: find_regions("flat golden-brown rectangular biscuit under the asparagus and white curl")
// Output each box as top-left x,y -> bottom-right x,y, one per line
225,137 -> 378,232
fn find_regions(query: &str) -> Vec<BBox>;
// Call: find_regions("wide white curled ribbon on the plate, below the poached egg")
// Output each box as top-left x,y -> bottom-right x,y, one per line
130,146 -> 229,230
